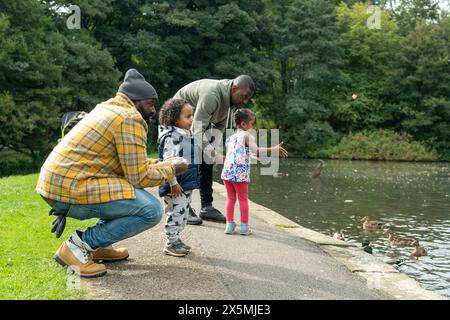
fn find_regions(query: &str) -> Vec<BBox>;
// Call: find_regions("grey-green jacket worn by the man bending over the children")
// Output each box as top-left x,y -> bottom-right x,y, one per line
174,79 -> 233,156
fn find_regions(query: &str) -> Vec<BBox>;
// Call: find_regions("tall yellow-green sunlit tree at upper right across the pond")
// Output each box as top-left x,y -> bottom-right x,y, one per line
332,3 -> 401,133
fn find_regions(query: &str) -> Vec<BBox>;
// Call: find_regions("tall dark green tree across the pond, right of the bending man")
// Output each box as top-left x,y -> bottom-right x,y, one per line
269,0 -> 345,154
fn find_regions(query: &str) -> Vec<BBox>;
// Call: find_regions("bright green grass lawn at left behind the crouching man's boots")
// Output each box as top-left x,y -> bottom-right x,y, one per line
0,174 -> 95,300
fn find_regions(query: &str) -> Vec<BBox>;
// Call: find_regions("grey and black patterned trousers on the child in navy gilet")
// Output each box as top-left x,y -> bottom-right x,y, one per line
164,190 -> 192,245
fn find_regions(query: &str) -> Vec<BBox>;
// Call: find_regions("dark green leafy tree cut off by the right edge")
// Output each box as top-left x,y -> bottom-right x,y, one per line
391,18 -> 450,156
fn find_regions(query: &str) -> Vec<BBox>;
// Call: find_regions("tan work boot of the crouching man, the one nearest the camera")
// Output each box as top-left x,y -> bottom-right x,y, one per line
54,231 -> 106,278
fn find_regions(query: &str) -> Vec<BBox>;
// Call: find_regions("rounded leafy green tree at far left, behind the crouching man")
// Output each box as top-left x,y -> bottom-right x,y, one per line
0,1 -> 119,161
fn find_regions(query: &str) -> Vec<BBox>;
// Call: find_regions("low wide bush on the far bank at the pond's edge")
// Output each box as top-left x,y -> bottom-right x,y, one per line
324,129 -> 439,161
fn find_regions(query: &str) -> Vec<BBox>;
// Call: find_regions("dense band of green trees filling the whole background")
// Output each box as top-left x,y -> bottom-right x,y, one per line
0,0 -> 450,170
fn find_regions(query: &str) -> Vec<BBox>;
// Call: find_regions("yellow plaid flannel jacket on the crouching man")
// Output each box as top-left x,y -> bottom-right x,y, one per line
36,93 -> 174,204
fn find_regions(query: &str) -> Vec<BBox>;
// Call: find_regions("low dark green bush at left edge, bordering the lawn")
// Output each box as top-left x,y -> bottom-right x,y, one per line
0,151 -> 41,177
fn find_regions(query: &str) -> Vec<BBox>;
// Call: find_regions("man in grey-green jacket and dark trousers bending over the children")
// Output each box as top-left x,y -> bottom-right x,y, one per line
174,75 -> 255,224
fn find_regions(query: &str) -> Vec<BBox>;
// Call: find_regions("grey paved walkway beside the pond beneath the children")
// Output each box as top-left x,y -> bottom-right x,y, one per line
84,184 -> 391,300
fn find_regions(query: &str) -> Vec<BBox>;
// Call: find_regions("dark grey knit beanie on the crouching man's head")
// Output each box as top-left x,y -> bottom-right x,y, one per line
118,69 -> 158,100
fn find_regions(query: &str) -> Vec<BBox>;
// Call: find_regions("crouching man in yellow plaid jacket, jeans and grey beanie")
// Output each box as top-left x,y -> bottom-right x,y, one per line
36,69 -> 187,277
